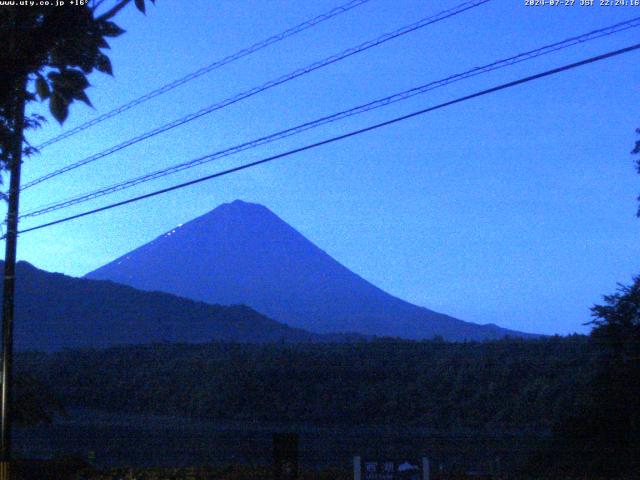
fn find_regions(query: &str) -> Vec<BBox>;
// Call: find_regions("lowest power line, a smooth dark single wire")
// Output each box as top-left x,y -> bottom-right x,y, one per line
13,43 -> 640,237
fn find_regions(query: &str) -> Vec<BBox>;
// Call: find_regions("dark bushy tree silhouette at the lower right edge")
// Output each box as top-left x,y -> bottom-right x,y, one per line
533,276 -> 640,478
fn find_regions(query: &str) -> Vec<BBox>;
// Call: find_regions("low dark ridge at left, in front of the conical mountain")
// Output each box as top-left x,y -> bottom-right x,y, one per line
0,262 -> 344,351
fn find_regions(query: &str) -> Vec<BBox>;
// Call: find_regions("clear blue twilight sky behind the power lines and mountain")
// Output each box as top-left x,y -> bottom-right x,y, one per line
5,0 -> 640,334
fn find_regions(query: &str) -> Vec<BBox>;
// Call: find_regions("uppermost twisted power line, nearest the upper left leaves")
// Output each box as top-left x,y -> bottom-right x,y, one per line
36,0 -> 370,150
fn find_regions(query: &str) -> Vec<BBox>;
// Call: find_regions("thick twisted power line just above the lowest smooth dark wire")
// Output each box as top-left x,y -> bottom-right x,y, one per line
20,17 -> 640,219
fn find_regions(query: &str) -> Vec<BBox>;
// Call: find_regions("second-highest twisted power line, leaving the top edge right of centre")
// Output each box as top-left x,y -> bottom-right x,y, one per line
22,0 -> 490,190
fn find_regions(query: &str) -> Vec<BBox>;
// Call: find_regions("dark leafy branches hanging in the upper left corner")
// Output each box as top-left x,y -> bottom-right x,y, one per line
0,0 -> 155,171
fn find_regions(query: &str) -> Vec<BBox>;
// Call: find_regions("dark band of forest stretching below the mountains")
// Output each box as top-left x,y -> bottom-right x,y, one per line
18,336 -> 598,432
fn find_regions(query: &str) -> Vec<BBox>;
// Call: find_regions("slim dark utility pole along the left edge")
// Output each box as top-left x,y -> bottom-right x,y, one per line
0,10 -> 27,480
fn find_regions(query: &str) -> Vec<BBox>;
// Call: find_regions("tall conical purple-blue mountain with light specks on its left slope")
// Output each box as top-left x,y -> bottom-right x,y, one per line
87,200 -> 536,340
